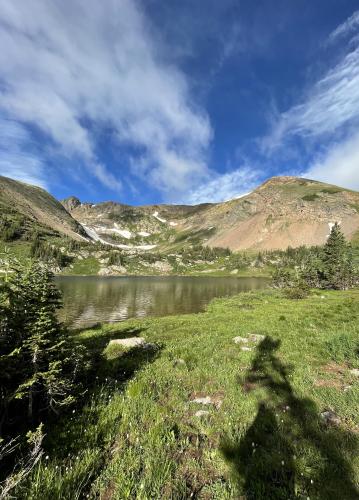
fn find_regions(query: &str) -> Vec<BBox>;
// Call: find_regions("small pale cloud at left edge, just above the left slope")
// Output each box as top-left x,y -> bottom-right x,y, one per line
0,118 -> 47,188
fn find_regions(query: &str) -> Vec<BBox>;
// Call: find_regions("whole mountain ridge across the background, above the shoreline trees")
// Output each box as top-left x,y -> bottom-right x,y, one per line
0,176 -> 359,250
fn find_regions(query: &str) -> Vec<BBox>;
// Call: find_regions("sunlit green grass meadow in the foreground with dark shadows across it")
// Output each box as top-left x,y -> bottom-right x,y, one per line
16,290 -> 359,500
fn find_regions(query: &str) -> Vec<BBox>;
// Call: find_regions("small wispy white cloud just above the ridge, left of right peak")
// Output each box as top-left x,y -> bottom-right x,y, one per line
183,166 -> 261,205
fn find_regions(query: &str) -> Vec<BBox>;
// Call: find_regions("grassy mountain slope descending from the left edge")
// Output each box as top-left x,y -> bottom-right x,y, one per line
0,176 -> 86,240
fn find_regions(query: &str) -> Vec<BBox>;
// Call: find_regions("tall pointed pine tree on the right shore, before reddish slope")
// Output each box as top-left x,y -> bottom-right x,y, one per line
323,223 -> 355,290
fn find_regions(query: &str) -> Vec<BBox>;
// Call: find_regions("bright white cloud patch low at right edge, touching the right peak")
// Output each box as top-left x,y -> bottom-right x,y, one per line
303,133 -> 359,190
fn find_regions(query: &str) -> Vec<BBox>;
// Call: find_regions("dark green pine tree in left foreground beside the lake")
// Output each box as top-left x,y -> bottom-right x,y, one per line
0,256 -> 82,431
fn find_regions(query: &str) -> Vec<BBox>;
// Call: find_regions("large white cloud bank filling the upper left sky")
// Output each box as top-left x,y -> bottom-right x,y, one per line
0,0 -> 212,193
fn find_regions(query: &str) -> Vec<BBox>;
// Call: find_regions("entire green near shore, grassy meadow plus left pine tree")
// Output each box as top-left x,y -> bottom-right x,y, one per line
0,270 -> 359,500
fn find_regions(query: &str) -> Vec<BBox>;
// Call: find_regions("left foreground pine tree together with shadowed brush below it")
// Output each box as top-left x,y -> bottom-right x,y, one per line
0,255 -> 85,498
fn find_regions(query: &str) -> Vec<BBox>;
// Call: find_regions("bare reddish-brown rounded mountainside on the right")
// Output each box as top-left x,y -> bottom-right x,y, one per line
195,177 -> 359,250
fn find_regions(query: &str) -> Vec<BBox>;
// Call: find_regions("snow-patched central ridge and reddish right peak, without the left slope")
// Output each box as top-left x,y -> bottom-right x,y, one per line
62,177 -> 359,252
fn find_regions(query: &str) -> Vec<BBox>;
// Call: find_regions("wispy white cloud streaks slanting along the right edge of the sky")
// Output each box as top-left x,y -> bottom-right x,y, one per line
260,11 -> 359,193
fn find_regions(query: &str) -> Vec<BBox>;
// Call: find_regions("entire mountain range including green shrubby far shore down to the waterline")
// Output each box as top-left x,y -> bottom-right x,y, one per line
0,177 -> 359,275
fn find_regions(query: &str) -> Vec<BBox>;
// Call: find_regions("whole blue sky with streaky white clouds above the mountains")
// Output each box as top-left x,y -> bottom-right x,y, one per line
0,0 -> 359,205
